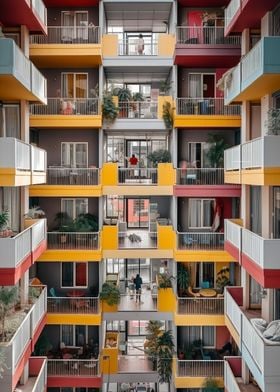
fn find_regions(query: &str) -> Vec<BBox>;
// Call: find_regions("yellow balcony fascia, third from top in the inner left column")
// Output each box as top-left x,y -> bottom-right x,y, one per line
29,185 -> 102,197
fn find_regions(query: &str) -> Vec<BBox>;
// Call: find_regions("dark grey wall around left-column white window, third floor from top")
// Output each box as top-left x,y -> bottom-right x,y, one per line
38,129 -> 98,167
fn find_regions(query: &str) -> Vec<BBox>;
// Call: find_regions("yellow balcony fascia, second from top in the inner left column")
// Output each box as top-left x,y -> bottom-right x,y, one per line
30,114 -> 102,129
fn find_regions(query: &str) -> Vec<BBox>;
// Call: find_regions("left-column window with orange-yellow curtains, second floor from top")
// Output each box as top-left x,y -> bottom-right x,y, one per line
61,72 -> 88,98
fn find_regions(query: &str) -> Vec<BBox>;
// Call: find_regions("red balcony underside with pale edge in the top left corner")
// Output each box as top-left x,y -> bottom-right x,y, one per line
0,0 -> 47,33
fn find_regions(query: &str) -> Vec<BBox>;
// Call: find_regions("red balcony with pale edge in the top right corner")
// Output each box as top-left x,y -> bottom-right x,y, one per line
225,0 -> 279,35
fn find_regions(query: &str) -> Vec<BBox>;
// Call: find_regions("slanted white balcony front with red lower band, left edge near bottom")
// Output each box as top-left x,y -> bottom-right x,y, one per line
0,288 -> 47,391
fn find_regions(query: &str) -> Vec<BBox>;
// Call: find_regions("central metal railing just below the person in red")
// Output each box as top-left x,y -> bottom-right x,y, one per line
119,166 -> 158,185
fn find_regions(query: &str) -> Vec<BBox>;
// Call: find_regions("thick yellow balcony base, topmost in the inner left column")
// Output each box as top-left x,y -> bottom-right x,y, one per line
30,44 -> 102,68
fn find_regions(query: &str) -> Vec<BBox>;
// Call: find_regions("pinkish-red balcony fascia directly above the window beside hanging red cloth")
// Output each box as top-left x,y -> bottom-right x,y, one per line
174,185 -> 241,197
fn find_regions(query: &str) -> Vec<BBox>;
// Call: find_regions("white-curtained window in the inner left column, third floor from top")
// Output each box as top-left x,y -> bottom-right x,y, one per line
61,142 -> 88,167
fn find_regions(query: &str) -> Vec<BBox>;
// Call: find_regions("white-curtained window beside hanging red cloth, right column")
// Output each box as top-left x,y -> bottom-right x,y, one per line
188,199 -> 214,229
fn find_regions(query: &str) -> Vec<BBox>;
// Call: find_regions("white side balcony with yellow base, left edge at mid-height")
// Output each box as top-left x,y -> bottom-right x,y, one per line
0,137 -> 47,186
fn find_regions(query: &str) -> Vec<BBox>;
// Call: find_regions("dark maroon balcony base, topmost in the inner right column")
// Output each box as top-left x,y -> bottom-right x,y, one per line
174,44 -> 241,68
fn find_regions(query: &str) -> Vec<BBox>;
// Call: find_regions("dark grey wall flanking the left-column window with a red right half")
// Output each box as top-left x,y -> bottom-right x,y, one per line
37,262 -> 99,297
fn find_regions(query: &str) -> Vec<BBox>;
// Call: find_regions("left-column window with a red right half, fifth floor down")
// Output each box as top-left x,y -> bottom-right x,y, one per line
61,262 -> 88,287
